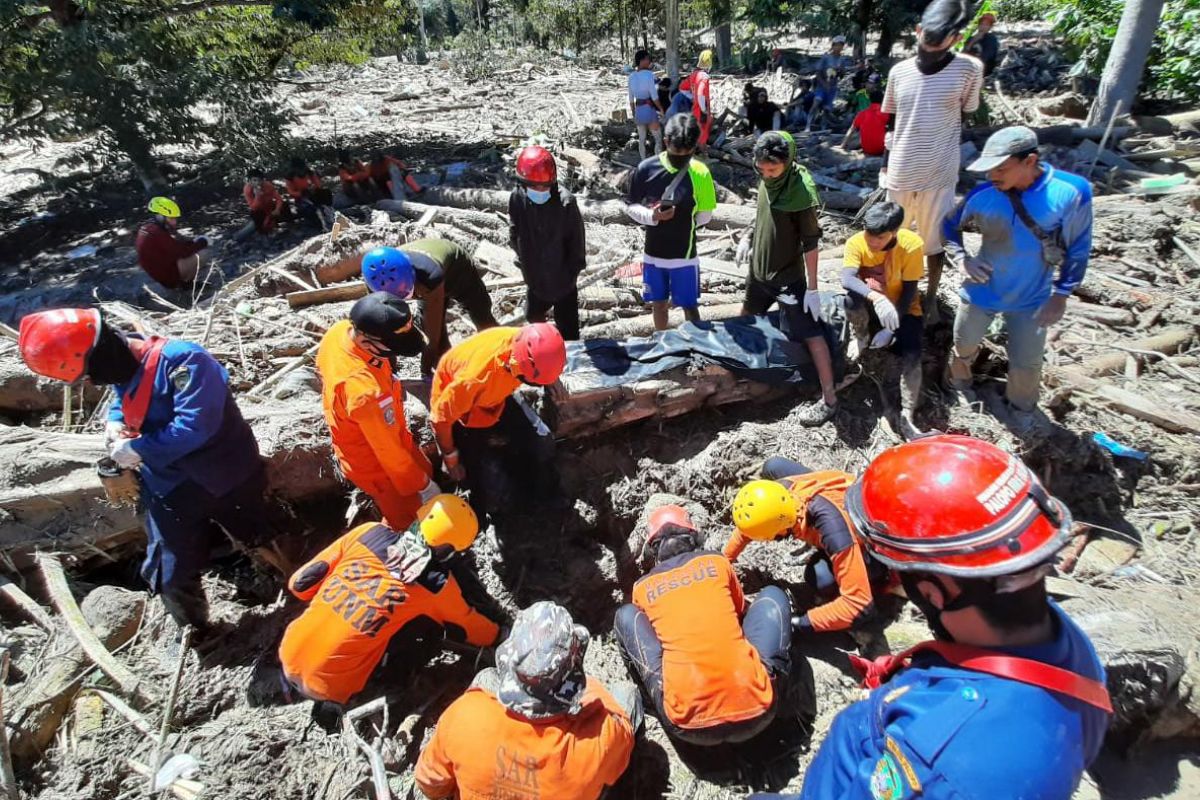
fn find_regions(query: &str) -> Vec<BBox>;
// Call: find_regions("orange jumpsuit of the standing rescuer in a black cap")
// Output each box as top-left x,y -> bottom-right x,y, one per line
317,319 -> 433,530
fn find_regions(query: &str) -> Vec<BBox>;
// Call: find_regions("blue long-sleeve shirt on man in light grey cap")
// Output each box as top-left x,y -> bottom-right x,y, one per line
942,166 -> 1092,312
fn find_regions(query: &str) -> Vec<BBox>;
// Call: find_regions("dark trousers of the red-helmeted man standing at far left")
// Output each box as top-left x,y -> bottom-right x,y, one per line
142,469 -> 274,628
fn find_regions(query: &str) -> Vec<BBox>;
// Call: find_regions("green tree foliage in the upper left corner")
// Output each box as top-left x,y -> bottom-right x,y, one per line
0,0 -> 404,190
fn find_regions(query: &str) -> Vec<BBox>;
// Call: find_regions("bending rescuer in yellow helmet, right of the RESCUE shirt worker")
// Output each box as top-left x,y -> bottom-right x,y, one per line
724,456 -> 888,632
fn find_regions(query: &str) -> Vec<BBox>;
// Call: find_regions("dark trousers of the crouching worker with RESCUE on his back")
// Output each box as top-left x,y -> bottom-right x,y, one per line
613,587 -> 792,747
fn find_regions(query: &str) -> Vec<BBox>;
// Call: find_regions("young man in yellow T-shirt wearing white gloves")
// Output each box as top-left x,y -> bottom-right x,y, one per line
841,201 -> 925,439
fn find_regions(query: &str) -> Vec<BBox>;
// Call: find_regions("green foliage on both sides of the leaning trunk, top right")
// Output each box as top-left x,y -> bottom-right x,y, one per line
1052,0 -> 1200,101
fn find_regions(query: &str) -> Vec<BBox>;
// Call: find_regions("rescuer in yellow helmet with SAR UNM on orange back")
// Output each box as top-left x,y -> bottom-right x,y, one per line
280,494 -> 499,716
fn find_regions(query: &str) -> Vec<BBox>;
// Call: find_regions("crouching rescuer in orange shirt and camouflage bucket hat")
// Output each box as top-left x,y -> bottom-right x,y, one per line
415,601 -> 642,800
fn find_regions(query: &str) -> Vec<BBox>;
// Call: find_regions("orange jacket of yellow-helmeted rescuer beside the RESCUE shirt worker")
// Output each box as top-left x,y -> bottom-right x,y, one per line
722,470 -> 872,631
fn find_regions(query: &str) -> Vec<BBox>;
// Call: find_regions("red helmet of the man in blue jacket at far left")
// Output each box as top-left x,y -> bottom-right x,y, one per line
17,308 -> 100,384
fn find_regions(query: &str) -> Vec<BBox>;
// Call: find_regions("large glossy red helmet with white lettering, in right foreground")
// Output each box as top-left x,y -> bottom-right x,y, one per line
846,435 -> 1072,578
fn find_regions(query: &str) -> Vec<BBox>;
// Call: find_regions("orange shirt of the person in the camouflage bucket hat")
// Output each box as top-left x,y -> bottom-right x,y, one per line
416,678 -> 634,800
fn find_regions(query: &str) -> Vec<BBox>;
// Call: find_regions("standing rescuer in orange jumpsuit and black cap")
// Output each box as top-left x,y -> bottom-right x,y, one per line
317,291 -> 439,530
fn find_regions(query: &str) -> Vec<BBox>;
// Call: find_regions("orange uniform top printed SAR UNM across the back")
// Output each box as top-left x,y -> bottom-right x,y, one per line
280,523 -> 499,703
